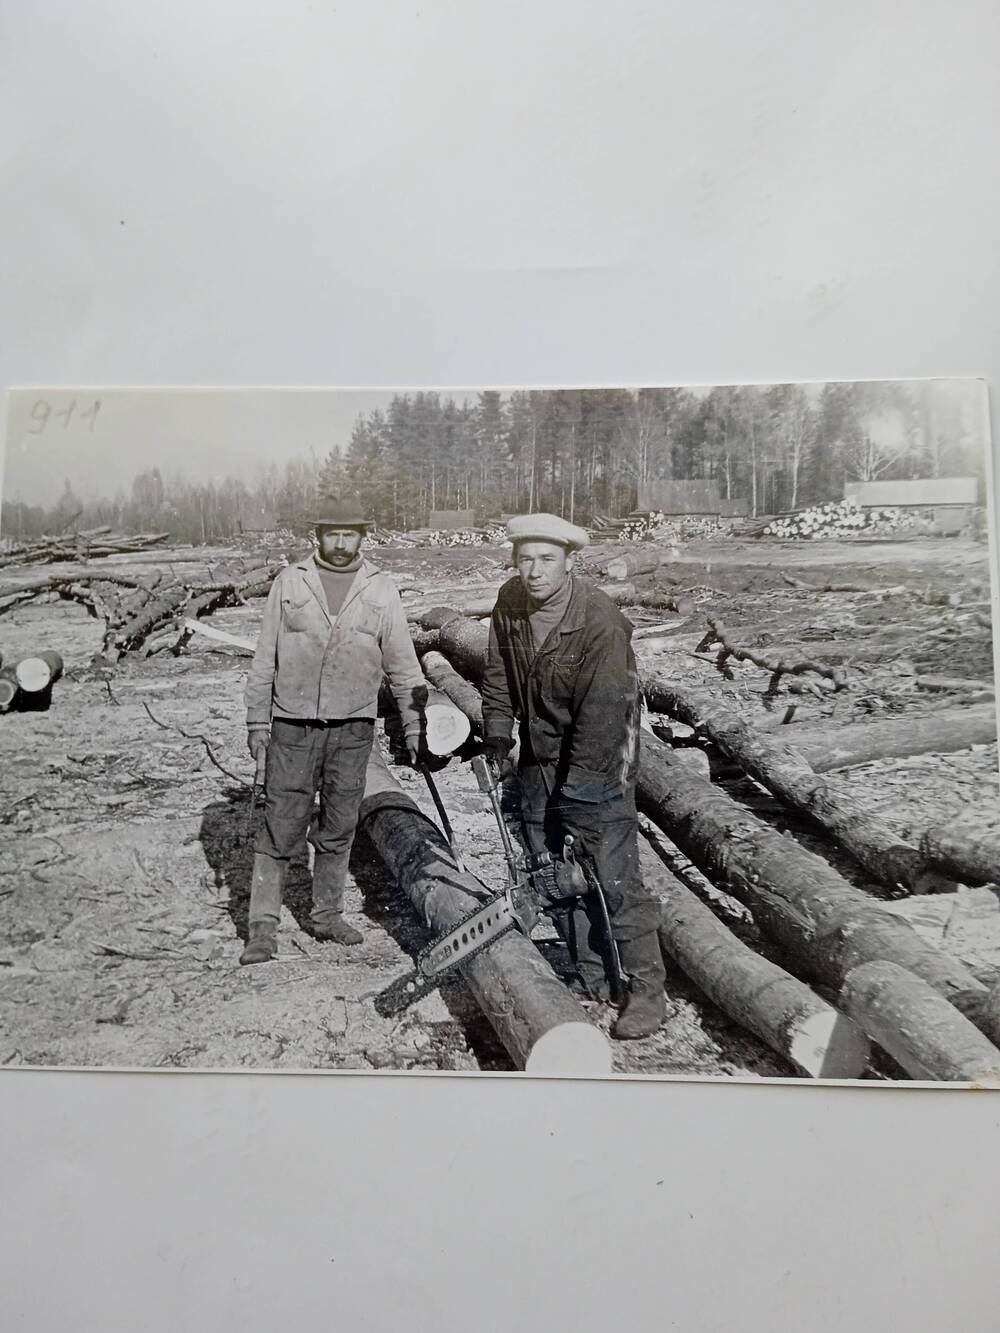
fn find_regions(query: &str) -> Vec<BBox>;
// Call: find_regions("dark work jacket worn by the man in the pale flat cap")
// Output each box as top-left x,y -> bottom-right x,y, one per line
483,577 -> 639,802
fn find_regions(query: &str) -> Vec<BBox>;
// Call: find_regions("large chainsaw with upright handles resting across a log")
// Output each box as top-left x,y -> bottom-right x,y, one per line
416,754 -> 591,981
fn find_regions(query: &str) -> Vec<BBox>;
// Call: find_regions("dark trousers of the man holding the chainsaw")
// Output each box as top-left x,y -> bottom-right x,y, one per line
519,764 -> 660,941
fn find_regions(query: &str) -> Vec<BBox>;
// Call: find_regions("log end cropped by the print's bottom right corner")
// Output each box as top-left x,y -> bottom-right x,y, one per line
840,961 -> 1000,1082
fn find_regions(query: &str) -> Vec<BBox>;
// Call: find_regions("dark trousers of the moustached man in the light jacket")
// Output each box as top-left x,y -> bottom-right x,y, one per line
255,717 -> 375,873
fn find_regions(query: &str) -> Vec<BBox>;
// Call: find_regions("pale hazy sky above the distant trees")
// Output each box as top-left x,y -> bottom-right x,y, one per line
0,380 -> 985,507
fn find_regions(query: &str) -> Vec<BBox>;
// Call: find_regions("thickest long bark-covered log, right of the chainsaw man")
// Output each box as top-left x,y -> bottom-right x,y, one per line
637,730 -> 985,1021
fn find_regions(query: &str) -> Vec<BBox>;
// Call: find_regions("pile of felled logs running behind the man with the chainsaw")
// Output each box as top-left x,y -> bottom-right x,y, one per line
405,608 -> 1000,1081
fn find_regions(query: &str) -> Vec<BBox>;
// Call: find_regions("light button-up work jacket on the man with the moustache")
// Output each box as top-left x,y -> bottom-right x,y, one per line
245,557 -> 427,736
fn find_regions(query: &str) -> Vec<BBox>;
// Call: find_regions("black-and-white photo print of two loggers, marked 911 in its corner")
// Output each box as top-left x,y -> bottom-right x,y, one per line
0,379 -> 1000,1084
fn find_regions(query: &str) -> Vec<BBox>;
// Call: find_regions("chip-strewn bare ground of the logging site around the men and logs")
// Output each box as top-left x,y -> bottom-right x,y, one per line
0,537 -> 1000,1080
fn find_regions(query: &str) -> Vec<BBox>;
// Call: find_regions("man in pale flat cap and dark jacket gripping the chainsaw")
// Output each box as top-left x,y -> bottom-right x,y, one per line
483,513 -> 665,1038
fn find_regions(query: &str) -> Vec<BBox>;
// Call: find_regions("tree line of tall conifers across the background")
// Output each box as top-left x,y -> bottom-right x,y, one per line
1,381 -> 984,544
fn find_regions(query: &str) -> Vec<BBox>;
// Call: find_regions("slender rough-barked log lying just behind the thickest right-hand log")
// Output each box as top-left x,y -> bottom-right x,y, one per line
643,677 -> 940,893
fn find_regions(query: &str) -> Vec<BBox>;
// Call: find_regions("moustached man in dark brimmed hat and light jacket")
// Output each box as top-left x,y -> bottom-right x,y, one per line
240,496 -> 427,964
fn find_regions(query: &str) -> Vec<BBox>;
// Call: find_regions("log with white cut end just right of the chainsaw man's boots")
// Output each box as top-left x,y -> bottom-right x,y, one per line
639,838 -> 869,1078
